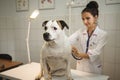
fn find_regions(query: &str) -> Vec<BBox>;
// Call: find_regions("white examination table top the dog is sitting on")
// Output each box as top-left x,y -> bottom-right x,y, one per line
0,62 -> 109,80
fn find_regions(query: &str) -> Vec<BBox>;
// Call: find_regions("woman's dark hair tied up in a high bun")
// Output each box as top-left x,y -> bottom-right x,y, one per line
82,1 -> 99,17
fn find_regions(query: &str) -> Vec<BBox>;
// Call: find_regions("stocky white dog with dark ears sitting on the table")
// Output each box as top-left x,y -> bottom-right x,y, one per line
36,20 -> 73,80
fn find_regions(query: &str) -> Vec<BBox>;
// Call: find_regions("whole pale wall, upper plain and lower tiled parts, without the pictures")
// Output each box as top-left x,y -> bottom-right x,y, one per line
0,0 -> 120,80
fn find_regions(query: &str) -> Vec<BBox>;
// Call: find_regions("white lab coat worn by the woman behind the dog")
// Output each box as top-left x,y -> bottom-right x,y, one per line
69,26 -> 107,73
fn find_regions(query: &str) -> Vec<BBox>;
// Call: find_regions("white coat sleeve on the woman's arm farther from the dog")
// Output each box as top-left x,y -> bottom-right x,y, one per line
88,33 -> 107,62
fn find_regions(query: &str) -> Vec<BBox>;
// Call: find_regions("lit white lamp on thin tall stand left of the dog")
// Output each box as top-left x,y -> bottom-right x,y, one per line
26,10 -> 39,63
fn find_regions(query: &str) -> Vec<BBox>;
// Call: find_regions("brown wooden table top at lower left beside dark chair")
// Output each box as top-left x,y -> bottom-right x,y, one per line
0,59 -> 22,72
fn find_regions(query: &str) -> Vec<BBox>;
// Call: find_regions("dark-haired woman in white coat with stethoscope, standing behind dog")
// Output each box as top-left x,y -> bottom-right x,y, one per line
69,1 -> 107,74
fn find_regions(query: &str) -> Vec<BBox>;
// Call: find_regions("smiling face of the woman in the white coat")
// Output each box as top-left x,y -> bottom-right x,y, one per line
82,12 -> 97,28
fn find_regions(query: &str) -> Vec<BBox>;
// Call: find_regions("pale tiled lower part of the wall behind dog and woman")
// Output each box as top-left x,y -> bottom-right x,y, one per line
0,13 -> 120,80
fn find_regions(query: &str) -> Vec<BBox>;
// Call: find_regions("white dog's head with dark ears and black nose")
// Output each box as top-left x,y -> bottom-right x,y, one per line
42,20 -> 69,42
